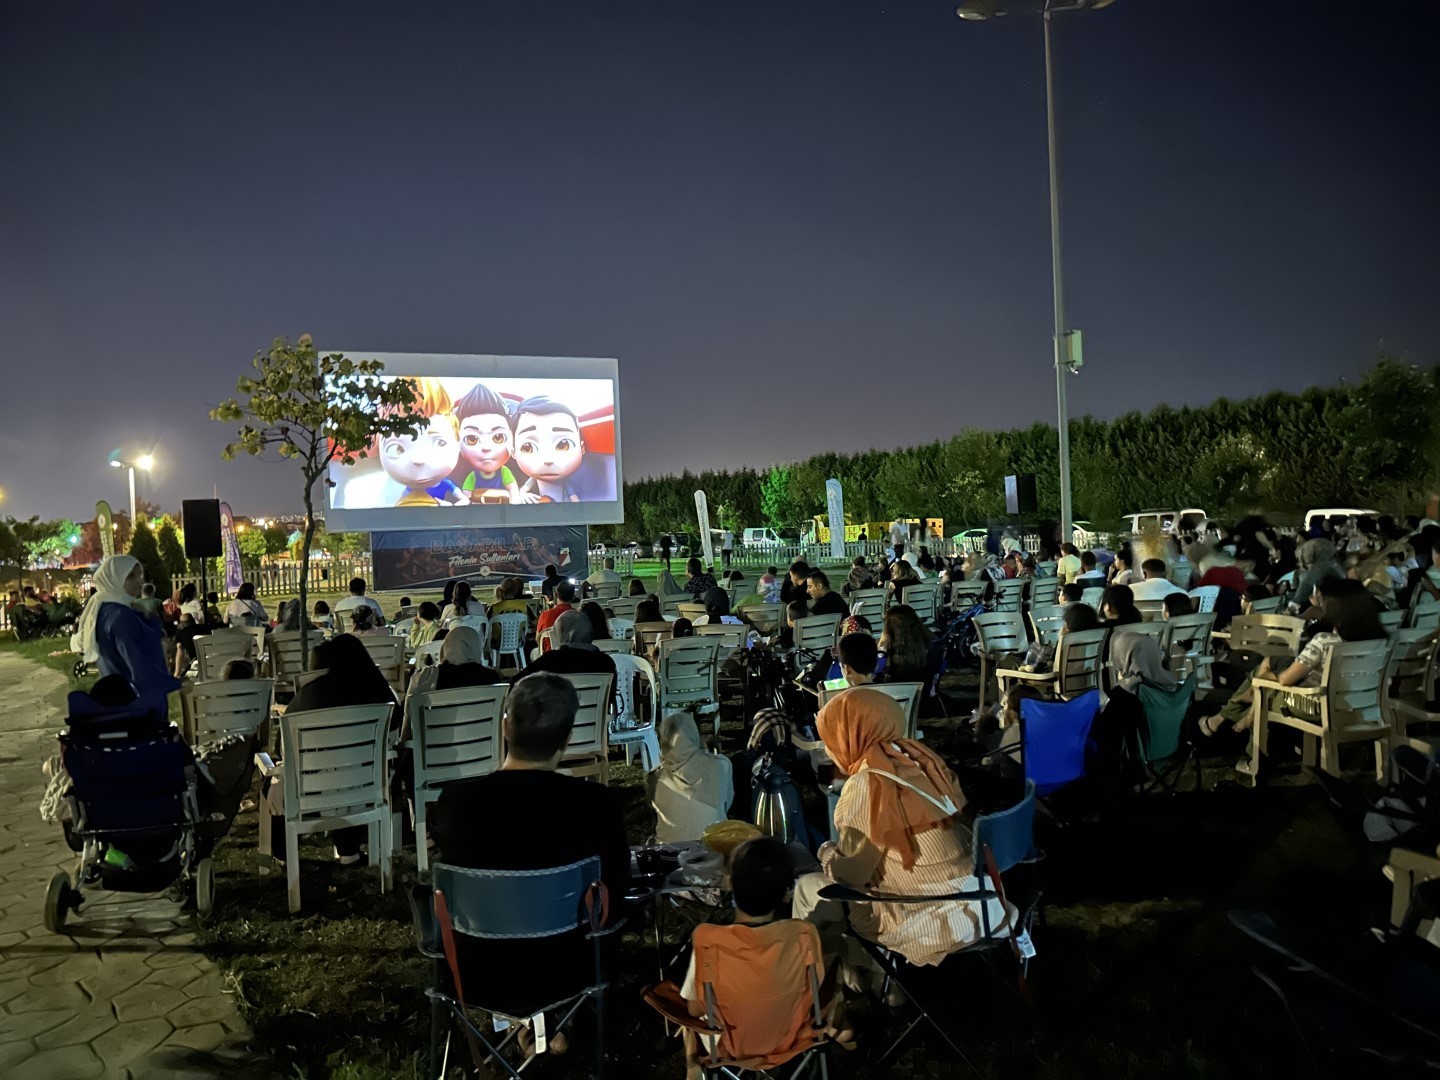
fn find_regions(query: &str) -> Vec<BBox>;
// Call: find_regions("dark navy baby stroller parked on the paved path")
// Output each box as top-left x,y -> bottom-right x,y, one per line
45,675 -> 215,933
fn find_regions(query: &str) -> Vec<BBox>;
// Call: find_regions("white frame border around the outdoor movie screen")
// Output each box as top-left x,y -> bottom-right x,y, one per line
321,350 -> 625,533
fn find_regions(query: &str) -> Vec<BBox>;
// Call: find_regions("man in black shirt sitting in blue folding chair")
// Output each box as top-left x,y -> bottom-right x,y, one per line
433,673 -> 629,1015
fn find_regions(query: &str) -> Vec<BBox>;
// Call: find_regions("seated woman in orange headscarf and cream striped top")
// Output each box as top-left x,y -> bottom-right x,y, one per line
793,687 -> 1014,965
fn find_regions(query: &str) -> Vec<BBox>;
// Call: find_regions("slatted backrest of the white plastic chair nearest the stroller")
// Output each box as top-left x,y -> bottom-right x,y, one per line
281,704 -> 392,821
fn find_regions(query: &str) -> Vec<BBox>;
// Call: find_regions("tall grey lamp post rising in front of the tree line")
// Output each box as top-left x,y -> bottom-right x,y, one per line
955,0 -> 1115,541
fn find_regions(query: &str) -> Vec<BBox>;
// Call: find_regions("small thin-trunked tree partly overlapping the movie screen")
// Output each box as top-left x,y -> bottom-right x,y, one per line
210,334 -> 426,665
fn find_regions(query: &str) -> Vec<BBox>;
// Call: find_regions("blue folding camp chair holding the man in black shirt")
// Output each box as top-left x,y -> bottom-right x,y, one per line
416,857 -> 624,1080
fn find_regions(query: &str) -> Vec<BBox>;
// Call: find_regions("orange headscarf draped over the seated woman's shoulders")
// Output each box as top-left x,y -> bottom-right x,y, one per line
815,687 -> 965,870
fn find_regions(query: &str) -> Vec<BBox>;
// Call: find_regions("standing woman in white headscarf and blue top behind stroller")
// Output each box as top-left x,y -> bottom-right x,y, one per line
78,554 -> 180,710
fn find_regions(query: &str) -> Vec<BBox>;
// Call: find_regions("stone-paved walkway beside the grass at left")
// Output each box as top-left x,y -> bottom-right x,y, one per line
0,654 -> 271,1080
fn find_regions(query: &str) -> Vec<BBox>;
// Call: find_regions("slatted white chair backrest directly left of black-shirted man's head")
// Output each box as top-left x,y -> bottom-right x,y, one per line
412,684 -> 510,792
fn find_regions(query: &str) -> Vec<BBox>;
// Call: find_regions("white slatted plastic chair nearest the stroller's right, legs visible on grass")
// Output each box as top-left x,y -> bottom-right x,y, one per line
259,704 -> 393,914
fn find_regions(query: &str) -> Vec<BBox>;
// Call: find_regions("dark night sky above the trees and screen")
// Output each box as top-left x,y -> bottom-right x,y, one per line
0,0 -> 1440,518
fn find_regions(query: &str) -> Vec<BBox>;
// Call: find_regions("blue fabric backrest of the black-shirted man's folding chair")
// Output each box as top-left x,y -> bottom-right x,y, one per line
431,855 -> 600,940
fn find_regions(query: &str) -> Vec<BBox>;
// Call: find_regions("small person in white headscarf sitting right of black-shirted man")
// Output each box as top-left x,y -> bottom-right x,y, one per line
645,713 -> 734,844
